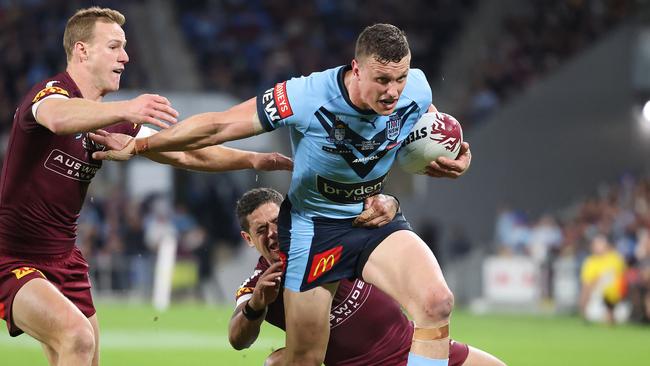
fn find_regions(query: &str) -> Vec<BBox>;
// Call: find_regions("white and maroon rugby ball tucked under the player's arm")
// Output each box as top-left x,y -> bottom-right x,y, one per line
397,112 -> 463,174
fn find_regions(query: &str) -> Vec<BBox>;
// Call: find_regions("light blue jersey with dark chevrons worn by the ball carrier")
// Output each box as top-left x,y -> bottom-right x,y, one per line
257,66 -> 431,218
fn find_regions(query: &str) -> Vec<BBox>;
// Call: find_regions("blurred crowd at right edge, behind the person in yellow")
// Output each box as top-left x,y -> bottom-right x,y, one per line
495,175 -> 650,322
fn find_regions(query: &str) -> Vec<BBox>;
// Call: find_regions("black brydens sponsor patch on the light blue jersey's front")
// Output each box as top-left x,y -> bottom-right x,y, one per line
316,174 -> 386,203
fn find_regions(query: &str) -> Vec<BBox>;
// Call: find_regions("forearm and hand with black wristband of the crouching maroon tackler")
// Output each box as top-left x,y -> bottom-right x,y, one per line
228,262 -> 282,350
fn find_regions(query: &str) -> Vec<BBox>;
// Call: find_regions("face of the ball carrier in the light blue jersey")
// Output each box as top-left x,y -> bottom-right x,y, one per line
352,55 -> 411,116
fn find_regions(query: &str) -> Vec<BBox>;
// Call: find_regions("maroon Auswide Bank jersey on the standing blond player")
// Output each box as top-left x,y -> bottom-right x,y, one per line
0,72 -> 140,256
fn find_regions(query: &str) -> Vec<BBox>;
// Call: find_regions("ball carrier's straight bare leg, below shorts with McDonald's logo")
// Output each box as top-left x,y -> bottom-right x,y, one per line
284,282 -> 338,366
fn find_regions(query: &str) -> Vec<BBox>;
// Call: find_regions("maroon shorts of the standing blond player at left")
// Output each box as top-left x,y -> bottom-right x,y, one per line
0,247 -> 95,337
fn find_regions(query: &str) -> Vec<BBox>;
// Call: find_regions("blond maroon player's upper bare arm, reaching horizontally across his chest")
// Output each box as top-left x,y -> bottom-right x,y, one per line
32,94 -> 178,135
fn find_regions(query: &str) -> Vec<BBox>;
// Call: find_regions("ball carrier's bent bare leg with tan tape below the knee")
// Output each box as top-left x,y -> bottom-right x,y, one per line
363,230 -> 454,365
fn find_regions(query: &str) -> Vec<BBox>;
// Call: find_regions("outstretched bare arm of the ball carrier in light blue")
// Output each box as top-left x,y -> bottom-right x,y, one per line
93,98 -> 262,160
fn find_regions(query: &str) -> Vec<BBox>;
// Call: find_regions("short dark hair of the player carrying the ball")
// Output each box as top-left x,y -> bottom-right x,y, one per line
354,23 -> 410,64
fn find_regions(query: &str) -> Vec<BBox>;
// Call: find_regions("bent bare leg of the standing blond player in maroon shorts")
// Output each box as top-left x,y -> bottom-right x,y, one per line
11,278 -> 95,365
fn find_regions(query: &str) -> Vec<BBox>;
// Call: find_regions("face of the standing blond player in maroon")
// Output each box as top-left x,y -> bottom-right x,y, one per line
87,22 -> 129,95
